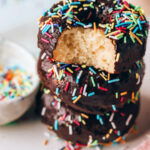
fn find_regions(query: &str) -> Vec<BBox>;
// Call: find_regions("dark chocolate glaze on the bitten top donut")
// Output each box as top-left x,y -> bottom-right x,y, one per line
38,0 -> 148,73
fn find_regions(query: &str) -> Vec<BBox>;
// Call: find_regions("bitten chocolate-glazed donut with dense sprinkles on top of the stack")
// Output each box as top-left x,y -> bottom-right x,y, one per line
38,0 -> 149,74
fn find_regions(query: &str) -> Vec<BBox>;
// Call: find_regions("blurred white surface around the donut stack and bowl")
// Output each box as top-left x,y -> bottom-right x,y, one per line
0,0 -> 150,150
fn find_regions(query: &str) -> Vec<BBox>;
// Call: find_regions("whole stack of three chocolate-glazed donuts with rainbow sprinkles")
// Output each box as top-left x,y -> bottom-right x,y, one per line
38,0 -> 148,146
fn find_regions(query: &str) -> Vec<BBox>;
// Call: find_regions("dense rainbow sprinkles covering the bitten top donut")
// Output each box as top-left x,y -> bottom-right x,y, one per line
39,0 -> 149,45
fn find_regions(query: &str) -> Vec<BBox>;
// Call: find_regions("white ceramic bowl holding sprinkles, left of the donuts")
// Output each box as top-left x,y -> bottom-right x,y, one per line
0,39 -> 39,125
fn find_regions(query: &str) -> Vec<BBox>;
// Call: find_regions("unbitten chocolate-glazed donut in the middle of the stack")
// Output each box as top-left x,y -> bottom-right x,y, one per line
38,54 -> 145,114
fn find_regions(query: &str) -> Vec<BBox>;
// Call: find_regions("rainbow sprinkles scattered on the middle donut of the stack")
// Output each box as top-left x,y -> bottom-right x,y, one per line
41,56 -> 143,106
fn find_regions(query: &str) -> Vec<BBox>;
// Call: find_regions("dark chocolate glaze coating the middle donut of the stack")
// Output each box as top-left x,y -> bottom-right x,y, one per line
38,51 -> 145,114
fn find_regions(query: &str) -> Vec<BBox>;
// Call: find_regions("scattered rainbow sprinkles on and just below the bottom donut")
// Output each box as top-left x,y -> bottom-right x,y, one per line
42,88 -> 138,150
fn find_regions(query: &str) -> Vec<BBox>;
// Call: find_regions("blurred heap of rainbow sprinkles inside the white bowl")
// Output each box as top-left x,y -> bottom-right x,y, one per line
0,66 -> 33,101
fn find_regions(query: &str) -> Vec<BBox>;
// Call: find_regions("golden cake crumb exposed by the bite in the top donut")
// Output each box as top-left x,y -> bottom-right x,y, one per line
53,27 -> 116,73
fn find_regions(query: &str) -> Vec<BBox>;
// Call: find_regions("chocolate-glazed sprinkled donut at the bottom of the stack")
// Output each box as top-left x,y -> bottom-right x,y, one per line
40,92 -> 140,145
